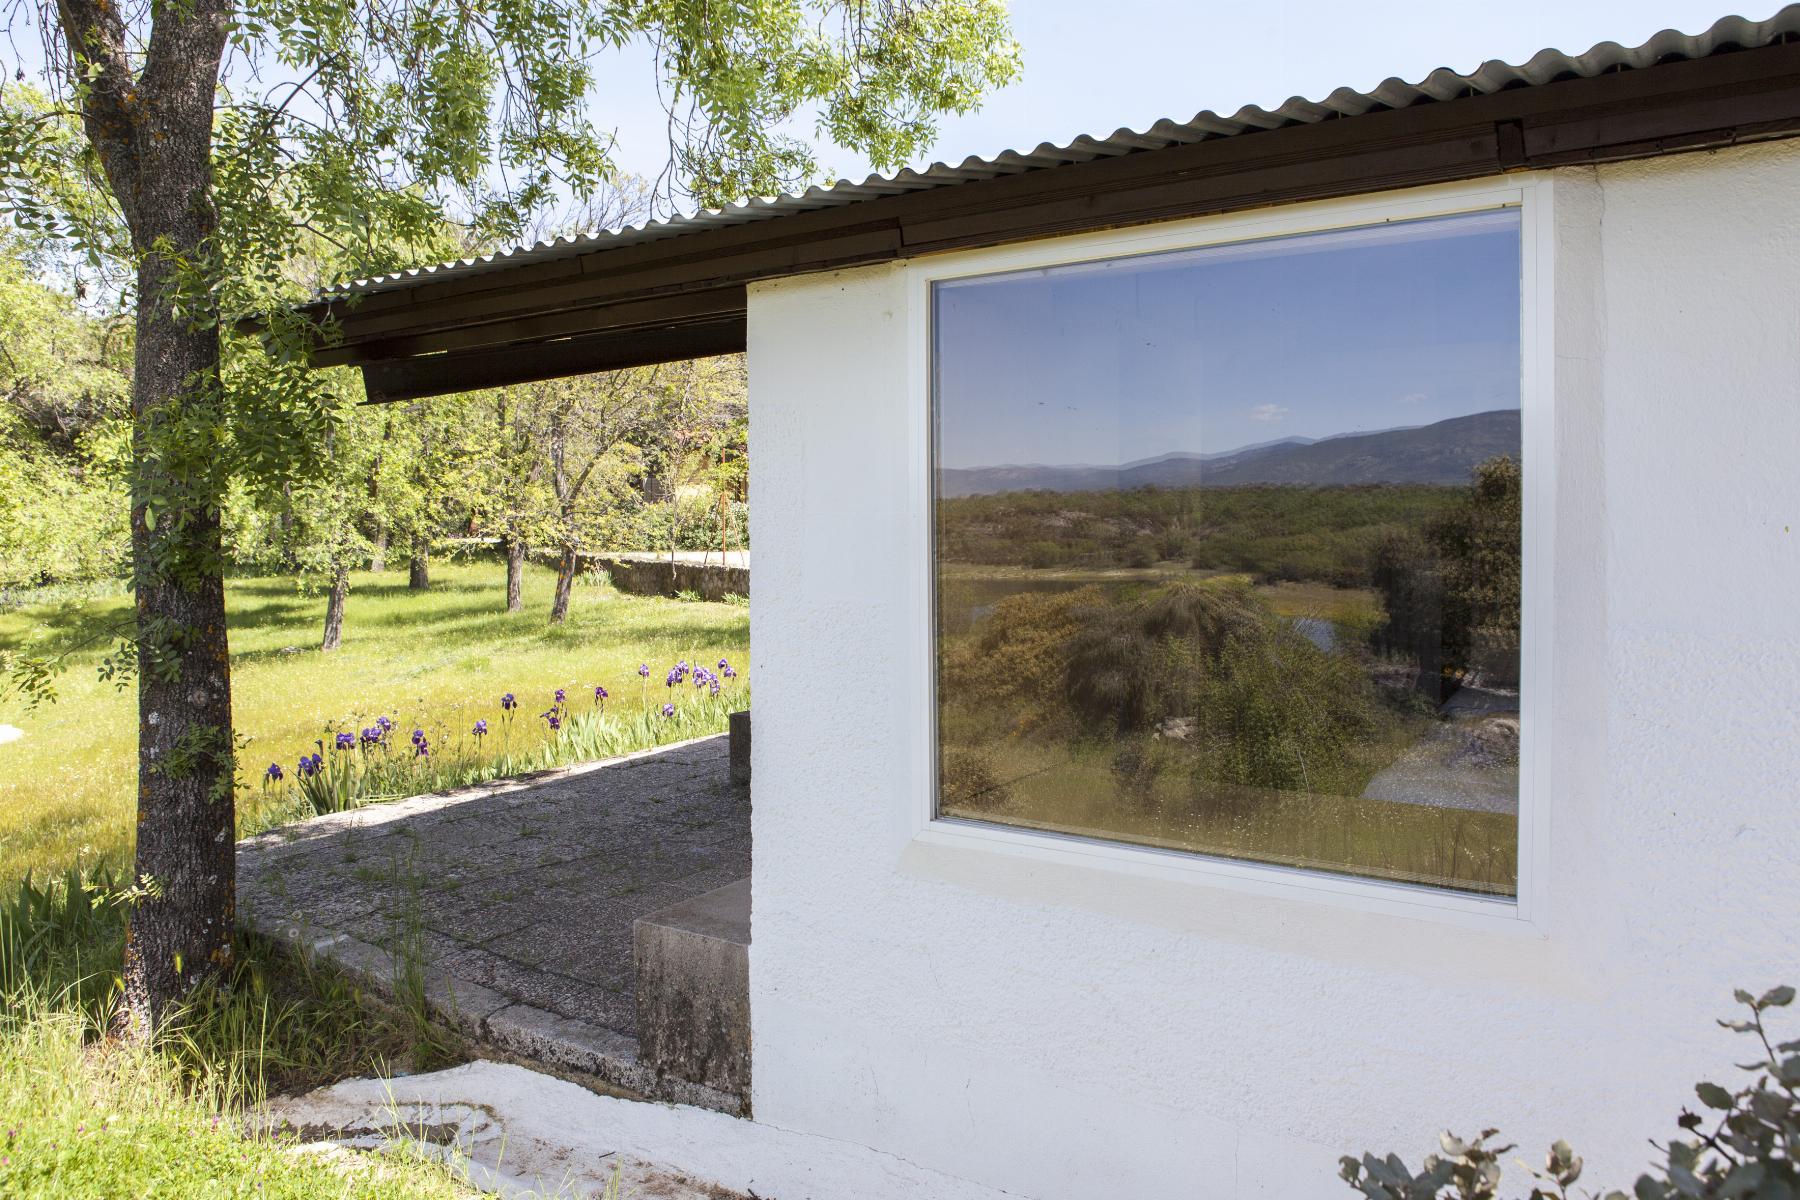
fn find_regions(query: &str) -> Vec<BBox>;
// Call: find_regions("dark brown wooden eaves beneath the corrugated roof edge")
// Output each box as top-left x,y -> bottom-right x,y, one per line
295,9 -> 1800,401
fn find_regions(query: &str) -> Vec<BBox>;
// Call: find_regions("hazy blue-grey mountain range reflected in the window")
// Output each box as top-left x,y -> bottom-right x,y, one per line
938,408 -> 1519,500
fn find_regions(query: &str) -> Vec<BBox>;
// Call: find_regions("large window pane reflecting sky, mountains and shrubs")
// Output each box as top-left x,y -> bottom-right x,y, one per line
931,207 -> 1532,896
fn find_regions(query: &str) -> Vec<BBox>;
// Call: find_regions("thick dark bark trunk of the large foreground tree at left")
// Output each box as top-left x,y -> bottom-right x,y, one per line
56,0 -> 238,1036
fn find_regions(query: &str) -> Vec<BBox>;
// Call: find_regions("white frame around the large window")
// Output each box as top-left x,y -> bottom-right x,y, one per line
898,175 -> 1555,937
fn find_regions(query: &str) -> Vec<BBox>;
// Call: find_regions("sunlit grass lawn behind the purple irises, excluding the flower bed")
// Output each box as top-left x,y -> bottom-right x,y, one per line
0,560 -> 751,882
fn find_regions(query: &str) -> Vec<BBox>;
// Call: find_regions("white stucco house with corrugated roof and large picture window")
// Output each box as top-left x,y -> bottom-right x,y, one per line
302,7 -> 1800,1200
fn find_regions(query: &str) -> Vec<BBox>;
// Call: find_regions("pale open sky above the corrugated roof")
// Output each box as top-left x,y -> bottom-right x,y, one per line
579,0 -> 1756,192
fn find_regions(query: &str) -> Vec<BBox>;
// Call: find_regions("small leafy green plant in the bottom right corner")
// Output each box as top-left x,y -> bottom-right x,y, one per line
1339,986 -> 1800,1200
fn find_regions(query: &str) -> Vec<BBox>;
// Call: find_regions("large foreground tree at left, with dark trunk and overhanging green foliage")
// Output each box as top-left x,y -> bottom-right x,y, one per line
0,0 -> 1017,1029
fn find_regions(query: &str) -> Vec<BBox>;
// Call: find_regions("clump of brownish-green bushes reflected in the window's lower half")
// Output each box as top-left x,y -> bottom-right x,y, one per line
941,581 -> 1417,810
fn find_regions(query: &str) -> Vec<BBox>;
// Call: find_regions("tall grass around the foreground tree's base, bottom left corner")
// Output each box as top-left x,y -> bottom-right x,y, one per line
0,871 -> 470,1200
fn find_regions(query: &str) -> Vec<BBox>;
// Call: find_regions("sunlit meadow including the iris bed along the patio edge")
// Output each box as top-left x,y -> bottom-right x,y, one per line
0,561 -> 749,880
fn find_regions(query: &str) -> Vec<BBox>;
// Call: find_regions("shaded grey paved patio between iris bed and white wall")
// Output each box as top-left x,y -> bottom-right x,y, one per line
238,736 -> 751,1110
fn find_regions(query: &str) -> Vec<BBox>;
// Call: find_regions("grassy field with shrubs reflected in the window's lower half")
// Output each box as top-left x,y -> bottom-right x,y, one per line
938,563 -> 1517,894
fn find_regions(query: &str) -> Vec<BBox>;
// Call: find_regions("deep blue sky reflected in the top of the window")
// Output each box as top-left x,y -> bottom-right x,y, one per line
934,209 -> 1519,468
